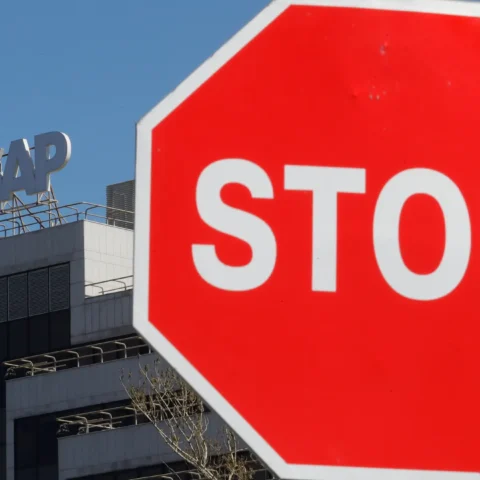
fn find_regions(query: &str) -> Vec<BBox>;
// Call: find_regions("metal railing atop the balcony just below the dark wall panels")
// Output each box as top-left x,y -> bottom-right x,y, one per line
3,335 -> 152,380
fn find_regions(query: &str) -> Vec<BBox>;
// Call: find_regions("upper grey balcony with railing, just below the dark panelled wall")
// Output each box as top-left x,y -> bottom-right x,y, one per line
4,336 -> 155,422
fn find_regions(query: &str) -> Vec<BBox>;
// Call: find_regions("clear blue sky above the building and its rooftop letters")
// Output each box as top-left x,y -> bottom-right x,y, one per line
0,0 -> 269,204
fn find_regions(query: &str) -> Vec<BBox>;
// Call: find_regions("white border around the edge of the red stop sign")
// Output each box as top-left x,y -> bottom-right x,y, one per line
133,0 -> 480,480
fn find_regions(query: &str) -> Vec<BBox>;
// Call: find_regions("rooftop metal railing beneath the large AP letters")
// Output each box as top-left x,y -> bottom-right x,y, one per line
0,202 -> 134,238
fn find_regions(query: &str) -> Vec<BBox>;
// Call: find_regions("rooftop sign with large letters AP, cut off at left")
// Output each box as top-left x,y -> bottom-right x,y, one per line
0,132 -> 71,202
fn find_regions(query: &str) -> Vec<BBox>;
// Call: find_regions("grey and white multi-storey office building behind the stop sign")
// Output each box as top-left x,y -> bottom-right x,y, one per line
0,182 -> 267,480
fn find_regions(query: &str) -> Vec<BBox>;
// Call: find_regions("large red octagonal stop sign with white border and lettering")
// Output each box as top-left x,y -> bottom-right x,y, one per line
134,0 -> 480,480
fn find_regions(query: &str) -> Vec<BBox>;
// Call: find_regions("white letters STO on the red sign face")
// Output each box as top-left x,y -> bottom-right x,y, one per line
192,159 -> 471,301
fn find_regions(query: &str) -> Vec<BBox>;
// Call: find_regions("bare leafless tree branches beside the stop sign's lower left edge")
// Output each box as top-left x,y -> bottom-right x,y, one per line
121,357 -> 273,480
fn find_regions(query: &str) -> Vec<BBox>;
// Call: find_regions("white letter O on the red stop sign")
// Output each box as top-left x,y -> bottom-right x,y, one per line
373,168 -> 471,300
